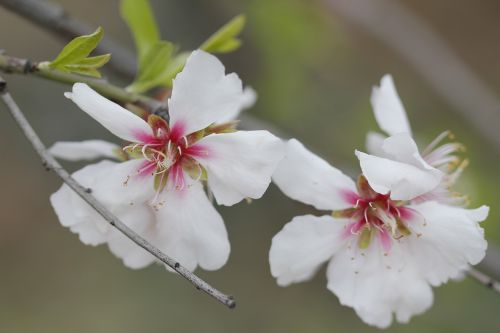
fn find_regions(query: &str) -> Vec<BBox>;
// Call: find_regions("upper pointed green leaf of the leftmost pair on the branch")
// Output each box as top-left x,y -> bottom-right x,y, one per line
49,27 -> 104,69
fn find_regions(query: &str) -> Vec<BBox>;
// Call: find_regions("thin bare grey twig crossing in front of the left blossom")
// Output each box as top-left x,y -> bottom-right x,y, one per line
0,77 -> 236,308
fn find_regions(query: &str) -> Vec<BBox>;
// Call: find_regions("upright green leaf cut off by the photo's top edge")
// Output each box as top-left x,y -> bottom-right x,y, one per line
120,0 -> 160,72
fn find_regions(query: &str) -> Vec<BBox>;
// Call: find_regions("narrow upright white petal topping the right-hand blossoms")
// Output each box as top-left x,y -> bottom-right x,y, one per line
371,75 -> 411,135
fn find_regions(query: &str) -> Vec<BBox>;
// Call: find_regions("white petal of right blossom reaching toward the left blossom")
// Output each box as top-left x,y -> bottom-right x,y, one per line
273,139 -> 357,210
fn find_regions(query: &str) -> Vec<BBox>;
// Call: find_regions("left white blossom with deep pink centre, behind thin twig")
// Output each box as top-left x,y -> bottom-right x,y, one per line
51,51 -> 284,270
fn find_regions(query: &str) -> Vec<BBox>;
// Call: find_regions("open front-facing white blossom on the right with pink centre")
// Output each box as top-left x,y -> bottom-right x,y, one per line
269,137 -> 488,328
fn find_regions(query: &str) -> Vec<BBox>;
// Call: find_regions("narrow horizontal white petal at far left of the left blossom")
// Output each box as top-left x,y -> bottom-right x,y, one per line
49,140 -> 120,161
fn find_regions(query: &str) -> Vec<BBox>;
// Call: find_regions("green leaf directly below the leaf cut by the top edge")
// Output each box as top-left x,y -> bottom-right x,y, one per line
127,41 -> 174,93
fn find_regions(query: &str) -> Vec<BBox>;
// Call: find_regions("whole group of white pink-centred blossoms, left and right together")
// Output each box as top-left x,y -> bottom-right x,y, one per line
51,51 -> 488,328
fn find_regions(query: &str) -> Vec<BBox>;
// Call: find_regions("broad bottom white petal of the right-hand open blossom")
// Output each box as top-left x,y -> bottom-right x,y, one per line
327,239 -> 433,328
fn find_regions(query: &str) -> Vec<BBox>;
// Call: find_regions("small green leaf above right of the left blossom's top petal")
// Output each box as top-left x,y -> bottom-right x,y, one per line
200,15 -> 246,53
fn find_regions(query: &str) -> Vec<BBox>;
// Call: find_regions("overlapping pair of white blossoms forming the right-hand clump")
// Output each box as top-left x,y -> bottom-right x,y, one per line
269,76 -> 488,328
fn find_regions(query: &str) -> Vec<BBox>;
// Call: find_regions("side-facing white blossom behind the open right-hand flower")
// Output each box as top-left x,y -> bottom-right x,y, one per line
356,75 -> 468,204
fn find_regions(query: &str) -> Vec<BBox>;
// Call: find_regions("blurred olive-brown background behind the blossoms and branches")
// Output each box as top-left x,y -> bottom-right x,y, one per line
0,0 -> 500,333
